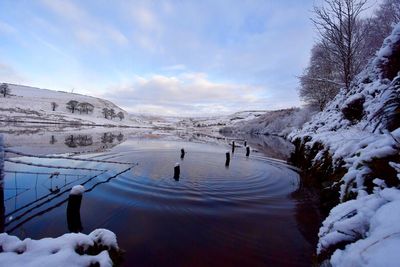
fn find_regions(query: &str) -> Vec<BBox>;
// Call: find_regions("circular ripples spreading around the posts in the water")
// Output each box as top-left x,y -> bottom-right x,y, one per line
89,149 -> 298,218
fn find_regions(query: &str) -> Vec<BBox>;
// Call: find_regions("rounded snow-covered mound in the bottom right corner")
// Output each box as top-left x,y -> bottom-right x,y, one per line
318,188 -> 400,267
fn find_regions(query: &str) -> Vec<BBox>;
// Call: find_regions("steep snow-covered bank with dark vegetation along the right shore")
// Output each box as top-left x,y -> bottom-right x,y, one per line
289,24 -> 400,266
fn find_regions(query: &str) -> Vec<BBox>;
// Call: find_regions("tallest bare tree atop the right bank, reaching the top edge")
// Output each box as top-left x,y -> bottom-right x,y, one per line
312,0 -> 367,88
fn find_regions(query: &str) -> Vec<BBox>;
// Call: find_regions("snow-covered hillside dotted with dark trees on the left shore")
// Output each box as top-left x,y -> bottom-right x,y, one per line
0,84 -> 144,125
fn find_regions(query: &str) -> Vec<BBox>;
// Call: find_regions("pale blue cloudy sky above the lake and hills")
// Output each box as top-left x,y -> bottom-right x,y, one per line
0,0 -> 316,115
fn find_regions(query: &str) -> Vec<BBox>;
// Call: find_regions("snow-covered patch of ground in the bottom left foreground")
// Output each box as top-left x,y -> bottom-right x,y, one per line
0,229 -> 118,267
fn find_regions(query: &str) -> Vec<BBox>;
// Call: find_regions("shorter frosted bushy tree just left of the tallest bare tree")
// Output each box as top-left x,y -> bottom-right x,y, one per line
299,43 -> 343,110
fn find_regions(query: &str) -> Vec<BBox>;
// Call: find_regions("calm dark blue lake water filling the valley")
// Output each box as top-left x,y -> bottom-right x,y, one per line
0,128 -> 316,266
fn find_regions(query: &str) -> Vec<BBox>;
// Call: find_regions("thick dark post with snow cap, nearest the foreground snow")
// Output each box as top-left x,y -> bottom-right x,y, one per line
67,185 -> 85,233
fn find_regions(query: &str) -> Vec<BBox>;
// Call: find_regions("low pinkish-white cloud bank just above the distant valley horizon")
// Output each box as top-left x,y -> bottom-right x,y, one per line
102,73 -> 276,115
